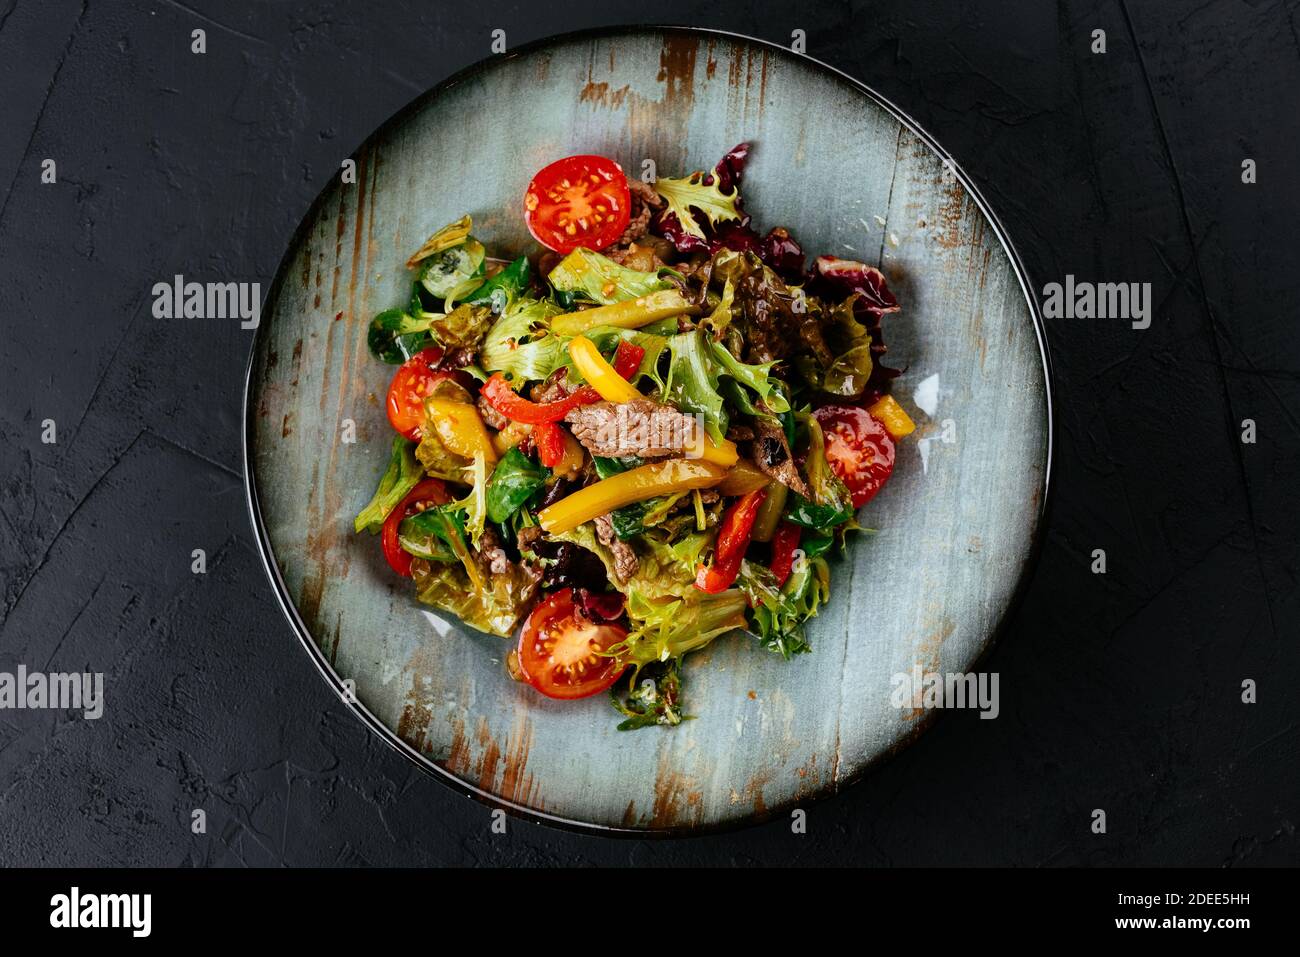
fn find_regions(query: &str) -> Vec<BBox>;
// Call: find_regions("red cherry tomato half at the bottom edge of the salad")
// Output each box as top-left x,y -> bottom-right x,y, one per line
519,588 -> 628,698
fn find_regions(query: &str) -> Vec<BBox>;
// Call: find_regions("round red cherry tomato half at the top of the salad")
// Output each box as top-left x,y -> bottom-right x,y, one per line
524,156 -> 632,252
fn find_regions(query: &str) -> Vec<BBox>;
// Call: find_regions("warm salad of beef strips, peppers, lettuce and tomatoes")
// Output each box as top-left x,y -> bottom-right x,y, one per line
355,144 -> 913,728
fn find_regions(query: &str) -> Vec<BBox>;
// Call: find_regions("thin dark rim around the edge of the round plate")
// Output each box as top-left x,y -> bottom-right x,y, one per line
241,23 -> 1056,840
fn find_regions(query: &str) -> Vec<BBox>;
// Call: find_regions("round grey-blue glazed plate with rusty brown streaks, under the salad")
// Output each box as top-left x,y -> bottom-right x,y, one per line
246,27 -> 1050,832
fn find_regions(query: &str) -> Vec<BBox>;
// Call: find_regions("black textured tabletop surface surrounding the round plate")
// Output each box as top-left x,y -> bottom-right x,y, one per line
0,0 -> 1300,866
